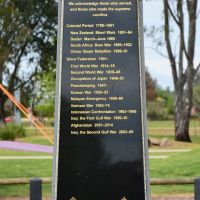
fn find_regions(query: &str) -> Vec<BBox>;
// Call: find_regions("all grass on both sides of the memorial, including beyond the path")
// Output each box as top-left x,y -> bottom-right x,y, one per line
0,121 -> 200,197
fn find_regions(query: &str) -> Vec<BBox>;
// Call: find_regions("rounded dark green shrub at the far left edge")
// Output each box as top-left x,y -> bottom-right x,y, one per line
0,124 -> 25,141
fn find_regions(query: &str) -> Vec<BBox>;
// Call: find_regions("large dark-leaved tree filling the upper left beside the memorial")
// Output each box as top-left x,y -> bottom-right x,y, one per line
0,0 -> 57,119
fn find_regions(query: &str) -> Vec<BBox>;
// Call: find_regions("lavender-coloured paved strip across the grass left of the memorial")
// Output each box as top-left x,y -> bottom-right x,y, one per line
0,141 -> 53,153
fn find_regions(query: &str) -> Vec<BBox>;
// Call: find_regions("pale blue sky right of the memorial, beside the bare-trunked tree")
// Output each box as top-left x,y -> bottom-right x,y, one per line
143,0 -> 200,90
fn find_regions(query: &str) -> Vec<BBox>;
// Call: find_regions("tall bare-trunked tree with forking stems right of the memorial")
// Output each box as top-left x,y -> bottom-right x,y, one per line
164,0 -> 200,142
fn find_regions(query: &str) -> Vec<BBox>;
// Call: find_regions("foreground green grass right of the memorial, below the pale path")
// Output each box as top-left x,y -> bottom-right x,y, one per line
150,148 -> 200,194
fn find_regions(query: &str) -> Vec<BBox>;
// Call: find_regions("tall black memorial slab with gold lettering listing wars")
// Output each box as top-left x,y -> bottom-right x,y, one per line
53,0 -> 149,200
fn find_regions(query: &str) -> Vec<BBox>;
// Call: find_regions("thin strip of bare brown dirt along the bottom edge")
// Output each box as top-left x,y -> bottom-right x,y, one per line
0,194 -> 194,200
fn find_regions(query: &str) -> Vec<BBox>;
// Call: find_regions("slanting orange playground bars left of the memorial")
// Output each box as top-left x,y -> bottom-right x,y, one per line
0,84 -> 53,144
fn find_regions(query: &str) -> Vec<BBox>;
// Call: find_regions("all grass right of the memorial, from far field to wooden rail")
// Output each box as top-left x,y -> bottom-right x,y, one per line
148,120 -> 200,194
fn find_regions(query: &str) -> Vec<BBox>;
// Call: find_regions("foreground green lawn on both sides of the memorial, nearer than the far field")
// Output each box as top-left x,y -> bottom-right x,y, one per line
0,144 -> 200,197
